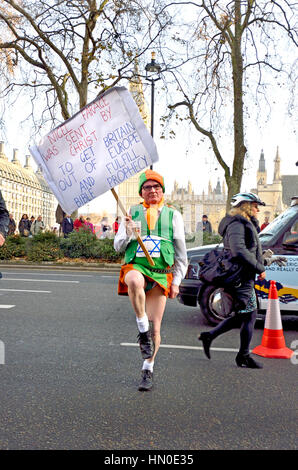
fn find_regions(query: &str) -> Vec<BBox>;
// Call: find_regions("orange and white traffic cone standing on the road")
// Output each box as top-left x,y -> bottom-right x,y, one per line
252,281 -> 294,359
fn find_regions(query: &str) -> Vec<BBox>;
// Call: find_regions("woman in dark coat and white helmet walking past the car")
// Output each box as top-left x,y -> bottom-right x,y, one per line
199,193 -> 269,369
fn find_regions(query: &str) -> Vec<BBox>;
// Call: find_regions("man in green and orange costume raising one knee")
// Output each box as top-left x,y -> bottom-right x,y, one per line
114,170 -> 187,391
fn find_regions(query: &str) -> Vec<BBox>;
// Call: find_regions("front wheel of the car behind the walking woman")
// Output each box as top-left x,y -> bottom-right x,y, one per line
199,286 -> 231,325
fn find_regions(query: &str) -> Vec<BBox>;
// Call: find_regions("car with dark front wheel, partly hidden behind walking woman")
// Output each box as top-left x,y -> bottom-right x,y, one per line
178,196 -> 298,325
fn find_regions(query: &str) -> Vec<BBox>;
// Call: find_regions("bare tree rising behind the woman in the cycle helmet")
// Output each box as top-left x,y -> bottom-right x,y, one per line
159,0 -> 298,203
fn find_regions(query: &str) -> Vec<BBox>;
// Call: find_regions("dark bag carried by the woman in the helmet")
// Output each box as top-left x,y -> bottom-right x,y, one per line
199,247 -> 243,288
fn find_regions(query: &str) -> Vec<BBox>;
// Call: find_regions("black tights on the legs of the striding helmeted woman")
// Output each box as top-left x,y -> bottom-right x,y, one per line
208,310 -> 257,355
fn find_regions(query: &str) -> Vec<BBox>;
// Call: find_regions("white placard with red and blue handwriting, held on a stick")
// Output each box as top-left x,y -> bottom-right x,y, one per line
30,87 -> 158,213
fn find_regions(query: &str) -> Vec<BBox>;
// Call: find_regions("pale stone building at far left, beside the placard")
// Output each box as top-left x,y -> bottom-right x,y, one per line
0,142 -> 57,228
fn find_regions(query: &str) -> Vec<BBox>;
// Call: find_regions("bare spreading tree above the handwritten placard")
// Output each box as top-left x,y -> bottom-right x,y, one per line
0,0 -> 169,138
